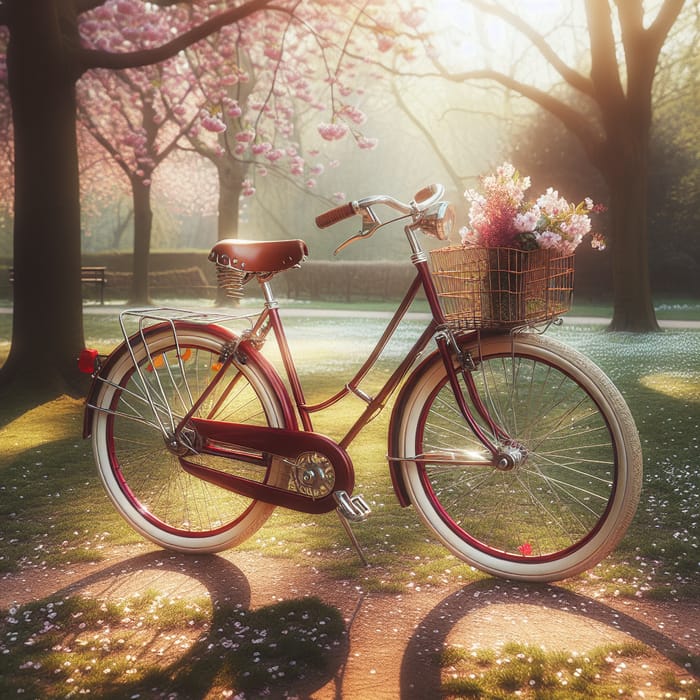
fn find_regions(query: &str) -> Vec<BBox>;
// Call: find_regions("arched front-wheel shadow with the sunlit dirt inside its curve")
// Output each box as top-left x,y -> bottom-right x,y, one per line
400,580 -> 700,699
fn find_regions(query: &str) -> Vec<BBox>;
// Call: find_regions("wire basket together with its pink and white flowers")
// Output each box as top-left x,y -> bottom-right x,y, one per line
431,163 -> 605,328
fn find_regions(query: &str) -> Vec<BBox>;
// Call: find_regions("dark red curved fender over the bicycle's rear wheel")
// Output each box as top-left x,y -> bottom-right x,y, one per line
83,321 -> 298,438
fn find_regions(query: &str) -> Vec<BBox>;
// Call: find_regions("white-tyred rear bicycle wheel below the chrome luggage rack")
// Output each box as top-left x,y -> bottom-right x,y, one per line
92,324 -> 288,552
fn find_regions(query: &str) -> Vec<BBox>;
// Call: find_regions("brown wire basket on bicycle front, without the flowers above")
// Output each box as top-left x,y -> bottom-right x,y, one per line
430,246 -> 574,330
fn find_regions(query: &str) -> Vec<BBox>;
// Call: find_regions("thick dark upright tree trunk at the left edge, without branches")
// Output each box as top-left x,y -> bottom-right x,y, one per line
0,0 -> 84,397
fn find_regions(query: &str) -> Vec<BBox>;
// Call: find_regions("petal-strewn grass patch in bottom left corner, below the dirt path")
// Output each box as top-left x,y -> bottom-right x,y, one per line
0,592 -> 345,700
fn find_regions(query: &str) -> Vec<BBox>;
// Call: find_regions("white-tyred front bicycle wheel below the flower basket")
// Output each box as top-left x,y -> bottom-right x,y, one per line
392,334 -> 642,581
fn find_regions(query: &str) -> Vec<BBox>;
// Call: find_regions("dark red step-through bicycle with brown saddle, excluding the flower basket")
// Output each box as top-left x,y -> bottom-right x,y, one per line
81,185 -> 642,581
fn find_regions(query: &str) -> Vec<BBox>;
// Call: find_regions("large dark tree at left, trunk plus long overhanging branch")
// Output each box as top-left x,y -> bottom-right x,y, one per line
0,0 -> 278,396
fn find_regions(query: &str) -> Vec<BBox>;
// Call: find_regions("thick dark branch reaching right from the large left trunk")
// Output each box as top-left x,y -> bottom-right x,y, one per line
78,0 -> 273,72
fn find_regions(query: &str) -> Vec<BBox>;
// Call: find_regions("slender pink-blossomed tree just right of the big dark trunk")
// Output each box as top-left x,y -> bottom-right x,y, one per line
78,0 -> 208,304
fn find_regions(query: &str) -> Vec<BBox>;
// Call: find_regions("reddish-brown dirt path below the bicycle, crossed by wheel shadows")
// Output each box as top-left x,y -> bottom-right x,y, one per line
0,545 -> 700,700
